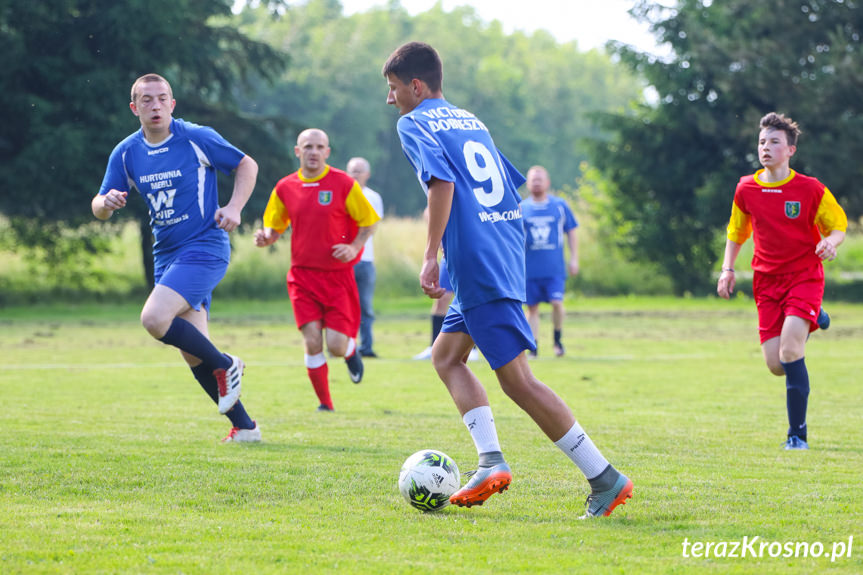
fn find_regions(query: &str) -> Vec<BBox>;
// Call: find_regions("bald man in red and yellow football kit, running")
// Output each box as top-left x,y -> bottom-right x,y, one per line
255,129 -> 380,411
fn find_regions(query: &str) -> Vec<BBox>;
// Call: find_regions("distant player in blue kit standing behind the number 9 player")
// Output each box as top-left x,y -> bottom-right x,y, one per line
521,166 -> 578,357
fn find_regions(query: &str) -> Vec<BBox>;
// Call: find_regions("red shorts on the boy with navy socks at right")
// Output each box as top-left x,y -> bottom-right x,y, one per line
752,266 -> 824,343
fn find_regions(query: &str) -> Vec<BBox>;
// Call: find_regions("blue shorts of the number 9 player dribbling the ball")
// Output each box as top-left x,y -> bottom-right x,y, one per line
441,299 -> 536,369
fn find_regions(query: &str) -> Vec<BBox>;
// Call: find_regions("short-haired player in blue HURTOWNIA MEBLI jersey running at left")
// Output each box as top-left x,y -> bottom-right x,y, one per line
91,74 -> 261,442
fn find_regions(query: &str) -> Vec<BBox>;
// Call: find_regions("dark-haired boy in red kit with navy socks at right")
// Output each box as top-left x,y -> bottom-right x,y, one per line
716,112 -> 848,449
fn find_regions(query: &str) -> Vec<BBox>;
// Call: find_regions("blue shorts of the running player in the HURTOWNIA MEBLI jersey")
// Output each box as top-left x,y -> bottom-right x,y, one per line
154,251 -> 228,311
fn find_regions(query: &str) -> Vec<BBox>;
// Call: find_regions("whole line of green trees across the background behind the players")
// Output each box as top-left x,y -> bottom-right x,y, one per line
0,0 -> 863,293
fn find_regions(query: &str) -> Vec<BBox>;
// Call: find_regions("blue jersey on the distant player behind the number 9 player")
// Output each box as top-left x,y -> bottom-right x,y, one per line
521,196 -> 578,279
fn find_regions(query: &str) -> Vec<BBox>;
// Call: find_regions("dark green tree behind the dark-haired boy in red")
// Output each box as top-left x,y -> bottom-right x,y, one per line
592,0 -> 863,293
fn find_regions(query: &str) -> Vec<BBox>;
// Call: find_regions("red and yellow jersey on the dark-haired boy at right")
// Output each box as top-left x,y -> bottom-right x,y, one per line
728,170 -> 848,274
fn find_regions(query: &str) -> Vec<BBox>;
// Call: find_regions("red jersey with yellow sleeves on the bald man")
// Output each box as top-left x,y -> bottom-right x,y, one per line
264,166 -> 380,270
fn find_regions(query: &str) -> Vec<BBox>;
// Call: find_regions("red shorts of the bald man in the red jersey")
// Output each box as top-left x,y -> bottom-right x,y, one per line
288,267 -> 360,337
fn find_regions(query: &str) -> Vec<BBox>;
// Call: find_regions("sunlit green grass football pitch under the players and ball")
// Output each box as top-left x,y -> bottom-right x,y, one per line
0,298 -> 863,574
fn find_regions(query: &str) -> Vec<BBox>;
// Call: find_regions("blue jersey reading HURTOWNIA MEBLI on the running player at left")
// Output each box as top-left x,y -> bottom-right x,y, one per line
99,119 -> 244,265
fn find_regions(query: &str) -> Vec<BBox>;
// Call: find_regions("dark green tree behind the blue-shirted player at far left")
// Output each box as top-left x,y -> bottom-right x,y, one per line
0,0 -> 286,288
